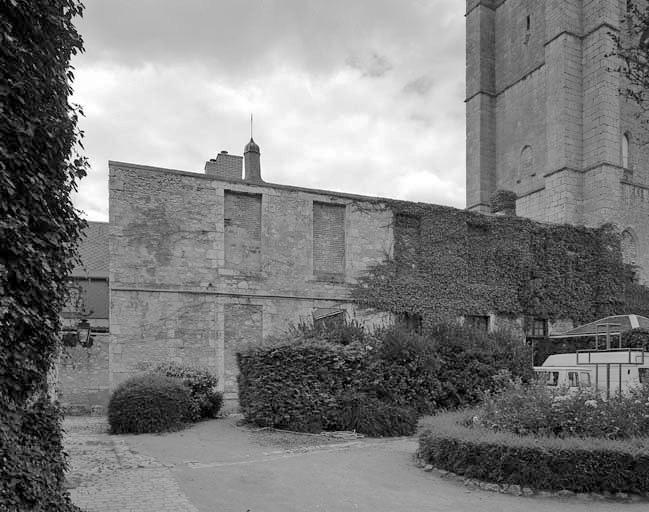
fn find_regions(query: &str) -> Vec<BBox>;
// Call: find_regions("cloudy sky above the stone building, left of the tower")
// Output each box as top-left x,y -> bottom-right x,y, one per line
73,0 -> 465,220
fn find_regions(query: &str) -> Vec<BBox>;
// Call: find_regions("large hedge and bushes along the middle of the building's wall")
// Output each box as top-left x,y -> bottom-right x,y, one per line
237,326 -> 532,435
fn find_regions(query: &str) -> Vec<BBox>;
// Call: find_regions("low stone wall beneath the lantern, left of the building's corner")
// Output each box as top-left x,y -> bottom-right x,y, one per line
57,334 -> 110,414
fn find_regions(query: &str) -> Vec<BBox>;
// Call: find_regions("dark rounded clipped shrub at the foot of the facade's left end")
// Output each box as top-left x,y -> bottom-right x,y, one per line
108,374 -> 191,434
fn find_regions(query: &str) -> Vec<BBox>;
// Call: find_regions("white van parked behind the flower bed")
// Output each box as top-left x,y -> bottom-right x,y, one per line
534,349 -> 649,395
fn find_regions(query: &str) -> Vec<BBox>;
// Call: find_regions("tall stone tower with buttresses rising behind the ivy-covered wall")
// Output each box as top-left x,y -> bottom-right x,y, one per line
466,0 -> 649,282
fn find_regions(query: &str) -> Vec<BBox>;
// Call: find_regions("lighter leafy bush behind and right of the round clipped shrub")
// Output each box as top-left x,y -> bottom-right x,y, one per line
152,363 -> 223,421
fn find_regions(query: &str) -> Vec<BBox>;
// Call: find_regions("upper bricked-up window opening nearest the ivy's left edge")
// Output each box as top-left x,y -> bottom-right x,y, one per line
313,201 -> 345,280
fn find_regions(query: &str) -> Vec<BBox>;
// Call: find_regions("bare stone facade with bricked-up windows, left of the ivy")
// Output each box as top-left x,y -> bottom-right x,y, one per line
109,147 -> 393,406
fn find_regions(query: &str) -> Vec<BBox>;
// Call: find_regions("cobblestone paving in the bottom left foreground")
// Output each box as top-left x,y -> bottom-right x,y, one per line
63,417 -> 198,512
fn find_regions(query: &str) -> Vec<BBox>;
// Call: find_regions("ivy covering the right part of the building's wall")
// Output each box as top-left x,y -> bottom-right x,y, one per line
353,201 -> 649,325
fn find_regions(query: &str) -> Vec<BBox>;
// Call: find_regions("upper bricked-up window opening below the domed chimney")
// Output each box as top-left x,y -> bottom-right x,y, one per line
223,190 -> 261,272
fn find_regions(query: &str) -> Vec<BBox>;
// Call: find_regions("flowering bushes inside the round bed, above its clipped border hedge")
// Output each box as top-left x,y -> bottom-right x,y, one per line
478,381 -> 649,439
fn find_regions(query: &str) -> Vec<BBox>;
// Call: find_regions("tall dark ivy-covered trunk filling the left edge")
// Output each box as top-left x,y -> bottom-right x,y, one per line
0,0 -> 87,511
